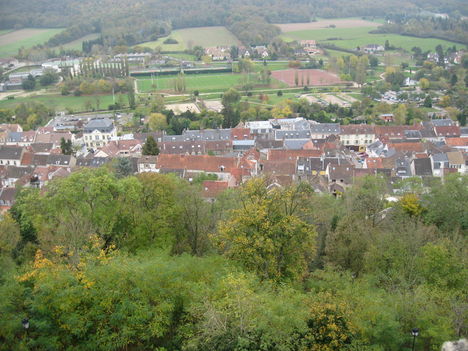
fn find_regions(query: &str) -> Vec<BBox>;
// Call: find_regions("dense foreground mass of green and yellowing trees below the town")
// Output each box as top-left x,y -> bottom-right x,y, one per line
0,169 -> 468,351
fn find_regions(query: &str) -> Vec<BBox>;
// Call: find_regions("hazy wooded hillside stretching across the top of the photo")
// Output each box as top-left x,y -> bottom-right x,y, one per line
0,0 -> 468,45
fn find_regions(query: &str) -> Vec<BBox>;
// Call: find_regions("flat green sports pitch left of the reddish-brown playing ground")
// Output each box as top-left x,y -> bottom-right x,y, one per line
137,73 -> 285,93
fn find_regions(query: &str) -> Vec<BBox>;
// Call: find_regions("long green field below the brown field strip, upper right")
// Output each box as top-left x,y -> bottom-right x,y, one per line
281,27 -> 463,51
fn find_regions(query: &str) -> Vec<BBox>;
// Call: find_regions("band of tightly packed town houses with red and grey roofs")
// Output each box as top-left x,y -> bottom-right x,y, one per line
0,116 -> 468,209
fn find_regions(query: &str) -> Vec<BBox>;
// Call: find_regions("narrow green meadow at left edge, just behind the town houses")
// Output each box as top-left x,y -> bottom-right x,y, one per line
0,94 -> 128,112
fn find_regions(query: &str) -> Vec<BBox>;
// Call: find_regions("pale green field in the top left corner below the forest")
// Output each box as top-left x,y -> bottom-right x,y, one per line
0,28 -> 62,57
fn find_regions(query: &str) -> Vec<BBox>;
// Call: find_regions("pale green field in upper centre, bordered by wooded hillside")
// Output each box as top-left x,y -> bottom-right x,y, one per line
139,27 -> 240,52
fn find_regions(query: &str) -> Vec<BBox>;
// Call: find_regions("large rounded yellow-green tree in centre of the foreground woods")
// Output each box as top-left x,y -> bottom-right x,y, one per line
213,178 -> 316,281
